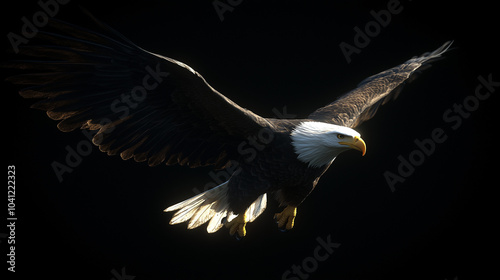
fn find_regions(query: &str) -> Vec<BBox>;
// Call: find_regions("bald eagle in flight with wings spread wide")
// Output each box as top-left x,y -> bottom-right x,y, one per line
4,15 -> 451,238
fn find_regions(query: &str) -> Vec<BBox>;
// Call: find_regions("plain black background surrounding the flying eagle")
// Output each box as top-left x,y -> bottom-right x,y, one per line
0,0 -> 500,280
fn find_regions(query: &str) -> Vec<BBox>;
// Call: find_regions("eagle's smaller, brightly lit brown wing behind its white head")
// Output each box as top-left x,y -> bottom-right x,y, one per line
309,41 -> 452,128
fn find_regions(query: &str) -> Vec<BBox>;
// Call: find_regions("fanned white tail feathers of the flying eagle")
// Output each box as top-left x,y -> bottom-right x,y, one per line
164,181 -> 267,233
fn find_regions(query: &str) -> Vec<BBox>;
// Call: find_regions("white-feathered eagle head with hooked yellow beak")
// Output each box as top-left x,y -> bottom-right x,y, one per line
291,121 -> 366,167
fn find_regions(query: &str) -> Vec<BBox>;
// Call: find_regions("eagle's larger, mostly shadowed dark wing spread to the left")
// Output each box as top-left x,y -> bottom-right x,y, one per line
4,19 -> 267,167
